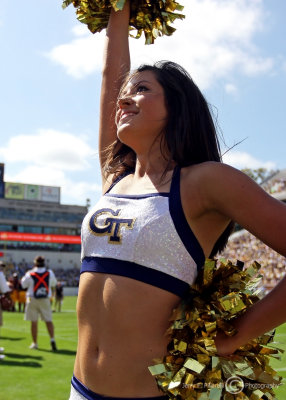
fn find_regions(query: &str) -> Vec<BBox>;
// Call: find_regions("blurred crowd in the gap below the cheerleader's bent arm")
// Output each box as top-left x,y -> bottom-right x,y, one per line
220,230 -> 286,294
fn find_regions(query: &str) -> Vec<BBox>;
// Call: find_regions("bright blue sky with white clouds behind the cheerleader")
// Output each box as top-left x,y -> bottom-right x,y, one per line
0,0 -> 286,205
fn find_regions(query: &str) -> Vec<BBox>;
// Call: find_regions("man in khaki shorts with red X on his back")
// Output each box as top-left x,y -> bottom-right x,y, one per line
21,256 -> 57,351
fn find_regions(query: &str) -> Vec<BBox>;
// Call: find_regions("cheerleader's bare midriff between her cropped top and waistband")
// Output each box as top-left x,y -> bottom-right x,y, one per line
74,272 -> 180,397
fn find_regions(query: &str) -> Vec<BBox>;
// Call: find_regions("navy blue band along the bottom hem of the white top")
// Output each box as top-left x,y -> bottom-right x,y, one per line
80,257 -> 189,297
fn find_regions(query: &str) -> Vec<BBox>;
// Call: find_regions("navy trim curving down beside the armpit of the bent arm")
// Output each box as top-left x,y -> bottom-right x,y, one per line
169,166 -> 205,269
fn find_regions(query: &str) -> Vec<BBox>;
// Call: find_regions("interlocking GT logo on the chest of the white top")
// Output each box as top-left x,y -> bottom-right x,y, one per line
89,208 -> 136,244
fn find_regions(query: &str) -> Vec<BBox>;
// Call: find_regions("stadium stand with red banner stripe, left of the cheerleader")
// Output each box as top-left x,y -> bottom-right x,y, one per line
0,164 -> 87,272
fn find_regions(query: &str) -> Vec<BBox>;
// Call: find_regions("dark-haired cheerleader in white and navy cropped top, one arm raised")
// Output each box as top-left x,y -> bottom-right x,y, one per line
70,1 -> 286,400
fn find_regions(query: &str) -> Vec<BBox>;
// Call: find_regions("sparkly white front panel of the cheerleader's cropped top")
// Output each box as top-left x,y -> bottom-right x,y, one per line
82,195 -> 200,285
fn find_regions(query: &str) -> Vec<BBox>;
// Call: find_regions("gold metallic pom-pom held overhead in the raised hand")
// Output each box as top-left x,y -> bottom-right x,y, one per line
62,0 -> 185,44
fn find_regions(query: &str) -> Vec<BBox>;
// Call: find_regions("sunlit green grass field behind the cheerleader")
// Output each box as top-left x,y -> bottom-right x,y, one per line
0,297 -> 286,400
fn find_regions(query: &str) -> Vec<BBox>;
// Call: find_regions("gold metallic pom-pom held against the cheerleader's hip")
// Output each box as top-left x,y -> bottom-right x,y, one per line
149,259 -> 283,400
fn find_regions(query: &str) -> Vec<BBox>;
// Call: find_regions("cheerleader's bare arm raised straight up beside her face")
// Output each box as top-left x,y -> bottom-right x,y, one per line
99,0 -> 130,185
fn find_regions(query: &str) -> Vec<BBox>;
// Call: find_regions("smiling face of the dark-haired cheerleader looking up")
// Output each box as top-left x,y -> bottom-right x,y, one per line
116,70 -> 167,147
